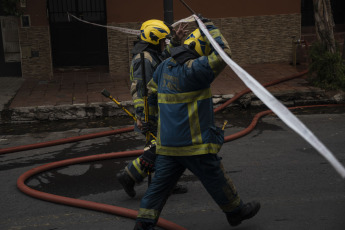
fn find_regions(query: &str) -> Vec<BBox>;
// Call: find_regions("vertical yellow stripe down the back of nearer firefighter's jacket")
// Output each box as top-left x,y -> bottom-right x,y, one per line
188,101 -> 202,145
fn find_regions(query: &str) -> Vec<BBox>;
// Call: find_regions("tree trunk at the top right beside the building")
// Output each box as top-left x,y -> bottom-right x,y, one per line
313,0 -> 336,53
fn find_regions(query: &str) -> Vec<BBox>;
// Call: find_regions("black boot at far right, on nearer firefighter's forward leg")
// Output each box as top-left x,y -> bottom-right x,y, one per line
226,201 -> 260,226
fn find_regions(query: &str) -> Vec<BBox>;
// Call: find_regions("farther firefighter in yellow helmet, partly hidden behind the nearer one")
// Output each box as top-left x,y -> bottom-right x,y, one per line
117,19 -> 188,197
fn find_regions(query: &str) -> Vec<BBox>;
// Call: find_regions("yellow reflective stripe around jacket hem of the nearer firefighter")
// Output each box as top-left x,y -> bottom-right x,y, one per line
157,143 -> 221,156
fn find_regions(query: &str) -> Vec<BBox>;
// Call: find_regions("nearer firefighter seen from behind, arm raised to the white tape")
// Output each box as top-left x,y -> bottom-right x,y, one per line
134,18 -> 260,230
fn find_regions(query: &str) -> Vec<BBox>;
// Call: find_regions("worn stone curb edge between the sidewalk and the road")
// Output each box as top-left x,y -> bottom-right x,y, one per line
0,89 -> 345,123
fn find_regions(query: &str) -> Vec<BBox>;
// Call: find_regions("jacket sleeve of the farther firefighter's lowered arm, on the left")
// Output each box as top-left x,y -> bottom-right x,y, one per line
130,52 -> 154,120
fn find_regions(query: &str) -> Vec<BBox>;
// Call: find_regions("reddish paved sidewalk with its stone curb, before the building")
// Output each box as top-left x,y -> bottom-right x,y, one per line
0,63 -> 345,122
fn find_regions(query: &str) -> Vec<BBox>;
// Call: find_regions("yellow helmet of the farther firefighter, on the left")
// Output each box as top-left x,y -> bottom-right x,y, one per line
140,19 -> 170,45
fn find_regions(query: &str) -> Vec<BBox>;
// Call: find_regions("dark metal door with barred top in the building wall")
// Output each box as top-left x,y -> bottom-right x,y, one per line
47,0 -> 108,67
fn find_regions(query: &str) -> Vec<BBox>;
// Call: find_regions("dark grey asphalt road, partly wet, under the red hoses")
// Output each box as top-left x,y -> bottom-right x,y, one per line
0,109 -> 345,230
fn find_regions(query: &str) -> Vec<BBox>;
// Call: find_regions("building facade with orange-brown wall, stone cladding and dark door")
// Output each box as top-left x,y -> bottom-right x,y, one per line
0,0 -> 342,79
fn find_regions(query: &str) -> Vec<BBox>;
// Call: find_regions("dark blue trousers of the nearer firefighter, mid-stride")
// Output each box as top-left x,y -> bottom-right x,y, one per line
137,154 -> 241,226
